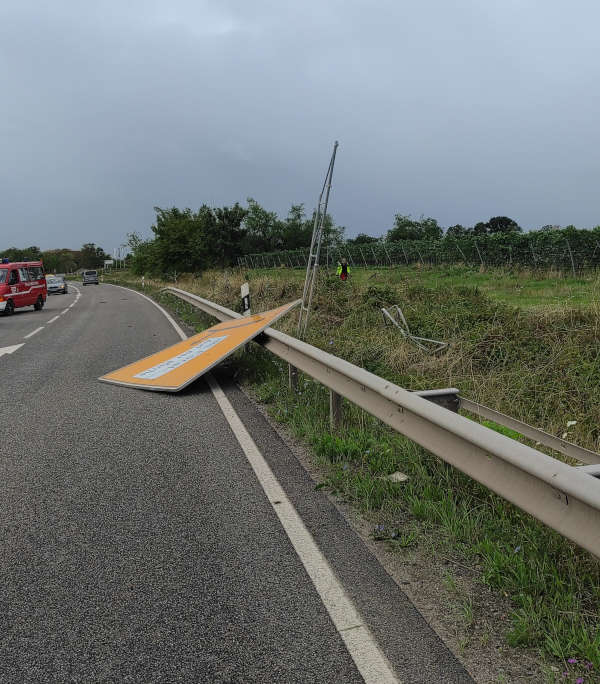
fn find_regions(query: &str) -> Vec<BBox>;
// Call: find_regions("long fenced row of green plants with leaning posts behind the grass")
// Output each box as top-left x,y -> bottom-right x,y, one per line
238,229 -> 600,277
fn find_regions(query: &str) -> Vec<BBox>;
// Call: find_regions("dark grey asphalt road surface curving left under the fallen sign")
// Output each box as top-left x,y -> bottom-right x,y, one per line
0,284 -> 471,682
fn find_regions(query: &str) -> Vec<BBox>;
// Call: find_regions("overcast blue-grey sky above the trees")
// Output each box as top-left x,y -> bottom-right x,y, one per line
0,0 -> 600,251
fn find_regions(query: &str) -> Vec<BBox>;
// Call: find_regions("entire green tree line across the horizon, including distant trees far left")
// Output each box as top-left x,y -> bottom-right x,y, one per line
5,198 -> 598,276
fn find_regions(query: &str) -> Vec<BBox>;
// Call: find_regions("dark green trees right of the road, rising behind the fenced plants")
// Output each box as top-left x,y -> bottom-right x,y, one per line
127,198 -> 556,275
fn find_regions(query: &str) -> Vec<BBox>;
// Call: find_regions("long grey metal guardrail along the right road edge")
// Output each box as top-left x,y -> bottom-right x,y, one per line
164,287 -> 600,557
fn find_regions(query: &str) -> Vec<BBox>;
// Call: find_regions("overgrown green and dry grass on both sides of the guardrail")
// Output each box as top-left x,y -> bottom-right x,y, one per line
108,267 -> 600,682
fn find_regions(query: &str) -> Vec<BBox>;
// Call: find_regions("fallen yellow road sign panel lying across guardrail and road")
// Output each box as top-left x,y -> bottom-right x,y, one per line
98,300 -> 300,392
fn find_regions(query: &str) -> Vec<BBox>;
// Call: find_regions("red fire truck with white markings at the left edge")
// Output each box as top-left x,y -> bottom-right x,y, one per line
0,259 -> 48,316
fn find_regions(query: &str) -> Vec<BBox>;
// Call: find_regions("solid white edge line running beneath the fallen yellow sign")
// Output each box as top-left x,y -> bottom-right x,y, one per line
113,285 -> 400,684
